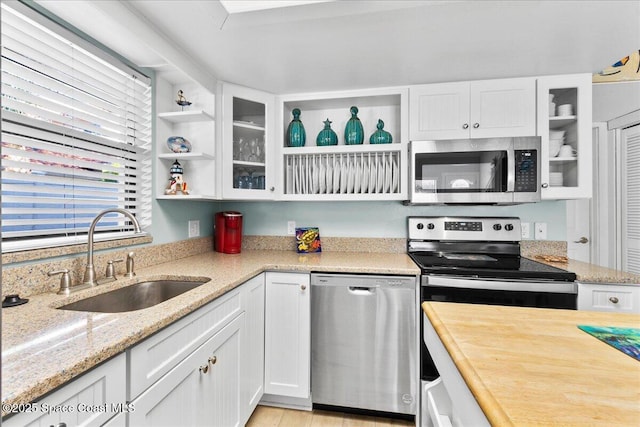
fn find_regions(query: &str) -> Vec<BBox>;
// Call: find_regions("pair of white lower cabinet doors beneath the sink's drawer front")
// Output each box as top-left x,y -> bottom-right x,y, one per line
129,314 -> 245,426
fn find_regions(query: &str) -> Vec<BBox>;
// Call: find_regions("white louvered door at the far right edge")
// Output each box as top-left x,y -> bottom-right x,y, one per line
620,125 -> 640,273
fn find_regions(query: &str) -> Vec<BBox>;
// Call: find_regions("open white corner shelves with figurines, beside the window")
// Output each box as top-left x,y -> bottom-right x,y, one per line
155,79 -> 218,200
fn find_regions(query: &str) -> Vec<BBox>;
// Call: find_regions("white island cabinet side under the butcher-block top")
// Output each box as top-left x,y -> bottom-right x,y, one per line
422,315 -> 490,427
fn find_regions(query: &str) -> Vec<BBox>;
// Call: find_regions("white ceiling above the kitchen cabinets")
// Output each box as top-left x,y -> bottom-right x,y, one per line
37,0 -> 640,94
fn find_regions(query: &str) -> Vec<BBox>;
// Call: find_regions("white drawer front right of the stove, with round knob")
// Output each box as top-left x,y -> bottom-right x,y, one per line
578,283 -> 640,313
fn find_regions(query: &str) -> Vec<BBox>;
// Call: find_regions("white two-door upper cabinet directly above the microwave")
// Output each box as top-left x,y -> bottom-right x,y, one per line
409,78 -> 536,141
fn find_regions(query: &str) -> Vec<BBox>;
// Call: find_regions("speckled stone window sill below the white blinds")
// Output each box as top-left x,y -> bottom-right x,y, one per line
2,234 -> 153,265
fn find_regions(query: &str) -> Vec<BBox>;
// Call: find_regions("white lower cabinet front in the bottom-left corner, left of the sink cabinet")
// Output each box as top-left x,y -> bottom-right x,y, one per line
2,353 -> 127,427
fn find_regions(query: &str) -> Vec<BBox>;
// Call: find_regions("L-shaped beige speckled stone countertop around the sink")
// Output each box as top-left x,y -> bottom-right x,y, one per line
2,251 -> 420,416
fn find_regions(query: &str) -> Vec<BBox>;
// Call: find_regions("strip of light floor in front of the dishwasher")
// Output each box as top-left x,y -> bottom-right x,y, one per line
247,405 -> 414,427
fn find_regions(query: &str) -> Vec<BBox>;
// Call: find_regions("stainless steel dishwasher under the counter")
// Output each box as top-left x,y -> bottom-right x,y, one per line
311,273 -> 418,415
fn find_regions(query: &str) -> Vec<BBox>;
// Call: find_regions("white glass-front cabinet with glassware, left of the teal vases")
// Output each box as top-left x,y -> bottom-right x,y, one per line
221,83 -> 276,200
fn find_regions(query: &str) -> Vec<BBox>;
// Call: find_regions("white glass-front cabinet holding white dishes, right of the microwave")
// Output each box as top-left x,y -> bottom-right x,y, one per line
538,74 -> 593,199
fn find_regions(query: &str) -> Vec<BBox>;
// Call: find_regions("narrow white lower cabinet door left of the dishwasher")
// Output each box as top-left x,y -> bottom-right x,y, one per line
264,272 -> 311,399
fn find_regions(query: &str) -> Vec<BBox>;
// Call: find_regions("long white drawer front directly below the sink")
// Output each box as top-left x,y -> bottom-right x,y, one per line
129,288 -> 242,399
